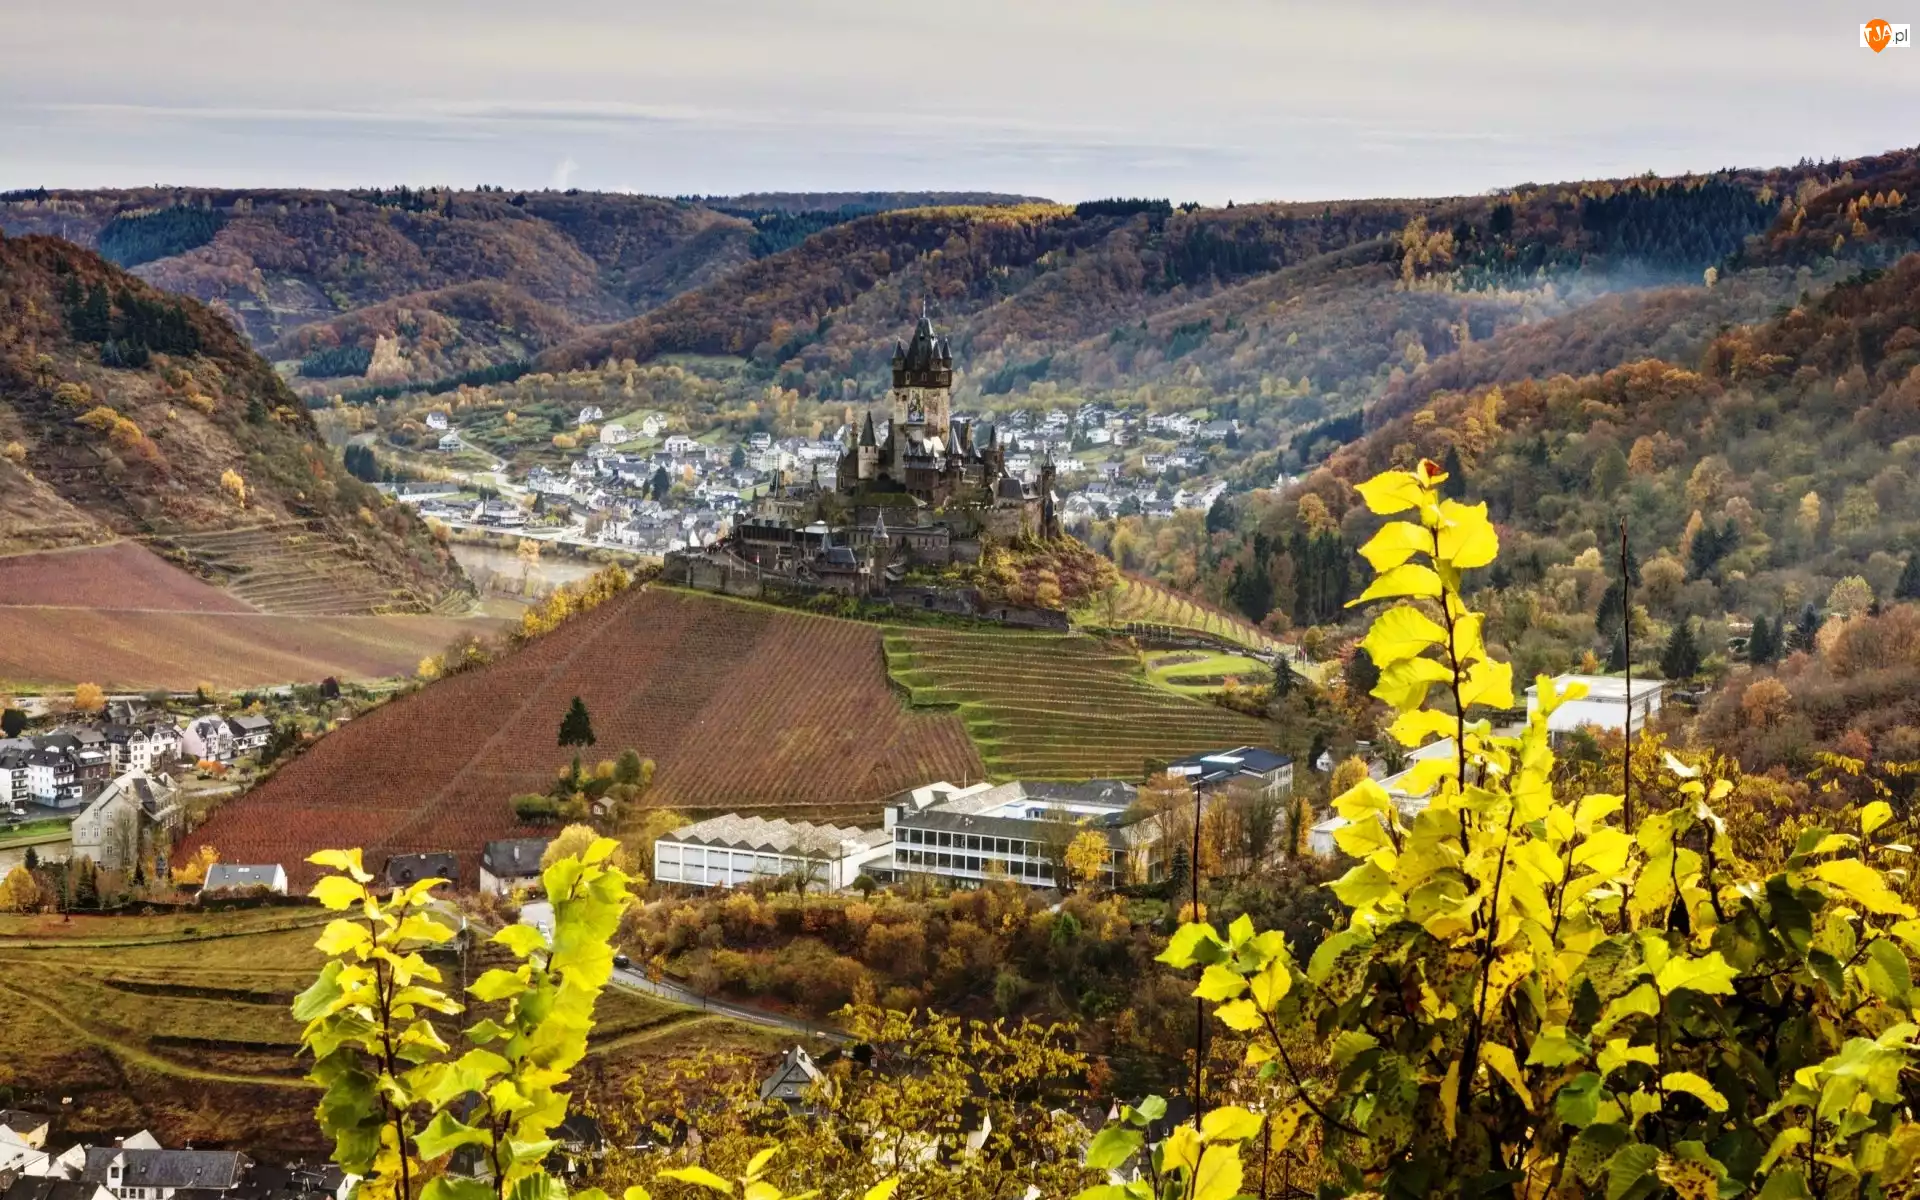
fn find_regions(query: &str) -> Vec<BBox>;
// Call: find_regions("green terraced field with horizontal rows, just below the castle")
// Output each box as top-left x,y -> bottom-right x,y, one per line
885,628 -> 1271,780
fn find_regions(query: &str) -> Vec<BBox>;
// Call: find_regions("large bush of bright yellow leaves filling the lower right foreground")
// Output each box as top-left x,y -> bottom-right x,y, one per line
1081,461 -> 1920,1200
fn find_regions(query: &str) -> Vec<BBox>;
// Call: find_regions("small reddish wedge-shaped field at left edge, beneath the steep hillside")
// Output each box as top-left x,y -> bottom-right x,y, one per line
0,541 -> 253,612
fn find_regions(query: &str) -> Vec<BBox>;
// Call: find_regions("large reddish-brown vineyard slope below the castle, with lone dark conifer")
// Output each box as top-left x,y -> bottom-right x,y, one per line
182,588 -> 985,885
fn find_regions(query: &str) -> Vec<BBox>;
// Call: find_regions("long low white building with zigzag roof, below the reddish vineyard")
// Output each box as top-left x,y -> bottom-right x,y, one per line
653,812 -> 893,891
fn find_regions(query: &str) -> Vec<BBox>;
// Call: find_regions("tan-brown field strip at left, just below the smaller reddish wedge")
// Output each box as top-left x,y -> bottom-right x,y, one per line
0,607 -> 499,691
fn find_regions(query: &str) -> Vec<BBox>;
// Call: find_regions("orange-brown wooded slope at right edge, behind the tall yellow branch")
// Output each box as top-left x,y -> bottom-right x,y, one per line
1136,245 -> 1920,691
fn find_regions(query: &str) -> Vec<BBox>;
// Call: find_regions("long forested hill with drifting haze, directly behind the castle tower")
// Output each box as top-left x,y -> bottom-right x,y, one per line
540,152 -> 1916,462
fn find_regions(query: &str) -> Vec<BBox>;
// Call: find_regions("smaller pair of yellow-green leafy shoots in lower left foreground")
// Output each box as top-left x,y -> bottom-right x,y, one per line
294,837 -> 643,1200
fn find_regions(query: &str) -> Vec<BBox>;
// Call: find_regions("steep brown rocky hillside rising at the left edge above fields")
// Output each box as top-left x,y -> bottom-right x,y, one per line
0,228 -> 461,607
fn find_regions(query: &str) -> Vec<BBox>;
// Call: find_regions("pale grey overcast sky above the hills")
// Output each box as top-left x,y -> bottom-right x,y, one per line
0,0 -> 1920,204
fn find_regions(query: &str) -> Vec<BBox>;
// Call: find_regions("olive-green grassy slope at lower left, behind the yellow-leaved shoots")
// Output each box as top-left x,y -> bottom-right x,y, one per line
0,908 -> 780,1152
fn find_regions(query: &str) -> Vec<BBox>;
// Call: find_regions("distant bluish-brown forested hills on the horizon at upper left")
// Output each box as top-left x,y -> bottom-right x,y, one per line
0,188 -> 1052,393
